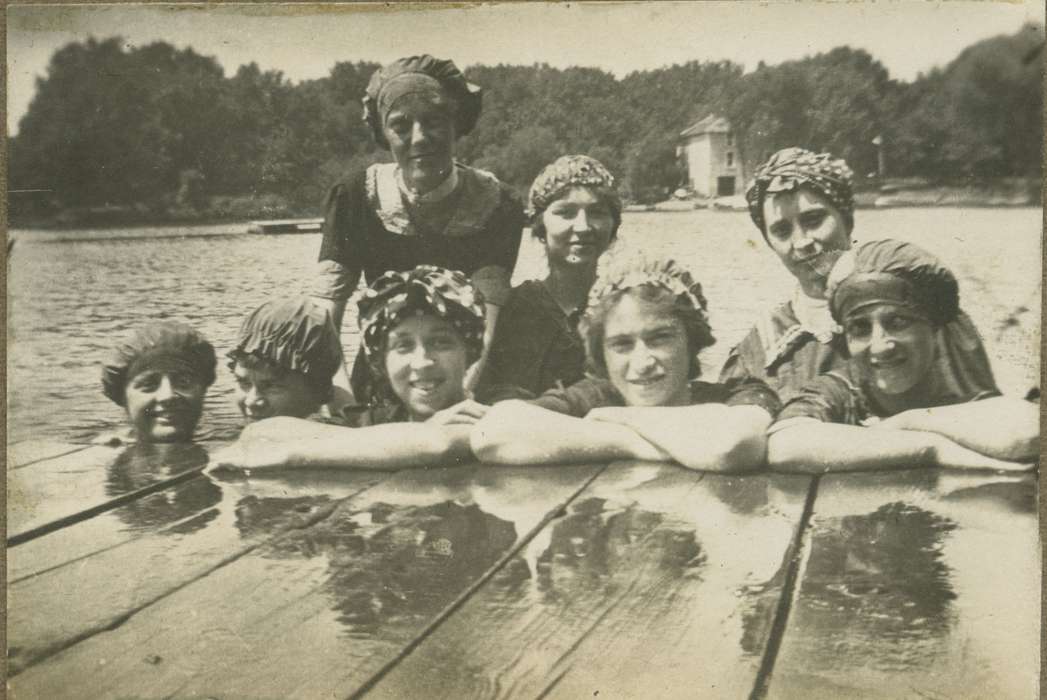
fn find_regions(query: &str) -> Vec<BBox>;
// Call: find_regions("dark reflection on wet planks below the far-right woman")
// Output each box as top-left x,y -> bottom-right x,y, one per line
801,502 -> 956,670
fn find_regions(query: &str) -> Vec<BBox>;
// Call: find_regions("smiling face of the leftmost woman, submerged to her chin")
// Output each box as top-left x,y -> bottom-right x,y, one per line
125,369 -> 207,443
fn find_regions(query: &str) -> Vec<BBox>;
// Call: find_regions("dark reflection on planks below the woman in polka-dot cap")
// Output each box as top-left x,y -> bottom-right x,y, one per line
257,499 -> 516,636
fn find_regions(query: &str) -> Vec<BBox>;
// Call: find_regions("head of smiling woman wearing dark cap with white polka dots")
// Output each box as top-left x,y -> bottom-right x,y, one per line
358,265 -> 485,420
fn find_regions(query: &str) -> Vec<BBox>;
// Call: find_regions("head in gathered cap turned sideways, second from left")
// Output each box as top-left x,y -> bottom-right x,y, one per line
227,297 -> 342,420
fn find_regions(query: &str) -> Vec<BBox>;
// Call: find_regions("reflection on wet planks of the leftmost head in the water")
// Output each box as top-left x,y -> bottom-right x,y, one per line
106,443 -> 222,534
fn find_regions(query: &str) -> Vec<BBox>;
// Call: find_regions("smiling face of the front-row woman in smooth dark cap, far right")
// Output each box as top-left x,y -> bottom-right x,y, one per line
844,303 -> 935,397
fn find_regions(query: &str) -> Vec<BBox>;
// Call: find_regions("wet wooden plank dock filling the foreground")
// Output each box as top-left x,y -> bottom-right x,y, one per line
7,444 -> 1041,700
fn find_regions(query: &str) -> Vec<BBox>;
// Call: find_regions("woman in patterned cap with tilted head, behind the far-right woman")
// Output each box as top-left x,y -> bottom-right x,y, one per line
720,148 -> 998,401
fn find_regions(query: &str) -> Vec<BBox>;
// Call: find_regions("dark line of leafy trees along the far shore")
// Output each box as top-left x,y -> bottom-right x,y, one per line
8,25 -> 1044,219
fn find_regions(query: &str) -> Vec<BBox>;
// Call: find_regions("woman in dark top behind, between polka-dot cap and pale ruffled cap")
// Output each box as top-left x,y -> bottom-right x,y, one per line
481,155 -> 622,394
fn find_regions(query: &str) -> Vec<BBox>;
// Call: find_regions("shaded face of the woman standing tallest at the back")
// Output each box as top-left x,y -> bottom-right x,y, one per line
382,92 -> 455,193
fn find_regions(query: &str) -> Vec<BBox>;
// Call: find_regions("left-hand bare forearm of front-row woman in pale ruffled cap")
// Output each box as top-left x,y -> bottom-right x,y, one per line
471,402 -> 660,465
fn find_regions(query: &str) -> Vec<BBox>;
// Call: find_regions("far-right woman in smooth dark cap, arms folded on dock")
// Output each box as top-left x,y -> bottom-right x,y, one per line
767,240 -> 1040,472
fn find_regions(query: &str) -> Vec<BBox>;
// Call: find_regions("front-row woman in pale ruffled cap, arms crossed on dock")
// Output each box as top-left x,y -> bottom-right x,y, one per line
472,254 -> 780,471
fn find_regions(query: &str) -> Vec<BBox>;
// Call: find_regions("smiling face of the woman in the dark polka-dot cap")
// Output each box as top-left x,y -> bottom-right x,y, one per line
385,314 -> 469,421
